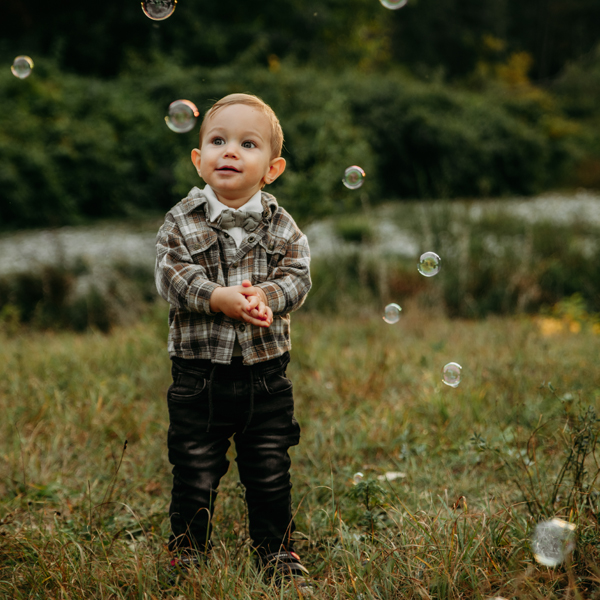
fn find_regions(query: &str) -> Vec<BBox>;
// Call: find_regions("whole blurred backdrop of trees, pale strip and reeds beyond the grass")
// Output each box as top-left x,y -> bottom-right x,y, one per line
0,0 -> 600,330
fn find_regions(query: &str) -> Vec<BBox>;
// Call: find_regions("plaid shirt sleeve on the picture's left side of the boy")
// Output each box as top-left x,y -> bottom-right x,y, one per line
154,213 -> 219,315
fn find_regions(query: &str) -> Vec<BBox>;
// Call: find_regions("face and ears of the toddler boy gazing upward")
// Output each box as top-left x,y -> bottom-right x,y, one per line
192,104 -> 285,208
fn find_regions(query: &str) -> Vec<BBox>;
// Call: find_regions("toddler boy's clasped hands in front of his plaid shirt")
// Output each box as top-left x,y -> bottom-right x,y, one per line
210,279 -> 273,327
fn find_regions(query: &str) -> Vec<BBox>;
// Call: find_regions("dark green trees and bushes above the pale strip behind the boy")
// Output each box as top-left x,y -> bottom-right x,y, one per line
0,0 -> 600,229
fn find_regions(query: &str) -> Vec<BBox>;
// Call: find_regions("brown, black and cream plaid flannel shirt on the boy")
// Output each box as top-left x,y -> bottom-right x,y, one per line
155,187 -> 311,365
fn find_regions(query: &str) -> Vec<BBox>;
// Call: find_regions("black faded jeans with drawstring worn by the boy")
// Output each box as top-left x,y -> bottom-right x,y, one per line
167,353 -> 300,553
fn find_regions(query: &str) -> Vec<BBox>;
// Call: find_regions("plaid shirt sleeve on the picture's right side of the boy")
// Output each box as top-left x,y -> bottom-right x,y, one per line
256,228 -> 312,315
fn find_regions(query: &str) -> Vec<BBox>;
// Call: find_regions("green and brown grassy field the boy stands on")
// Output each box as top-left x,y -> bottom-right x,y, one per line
0,300 -> 600,600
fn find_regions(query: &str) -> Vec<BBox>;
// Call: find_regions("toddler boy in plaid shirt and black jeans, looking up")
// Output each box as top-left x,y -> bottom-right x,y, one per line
155,94 -> 311,576
